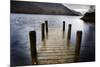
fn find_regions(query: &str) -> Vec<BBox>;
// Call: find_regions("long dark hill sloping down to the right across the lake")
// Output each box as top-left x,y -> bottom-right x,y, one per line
11,1 -> 81,16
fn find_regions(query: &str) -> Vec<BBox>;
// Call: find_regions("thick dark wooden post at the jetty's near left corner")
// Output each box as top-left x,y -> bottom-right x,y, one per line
29,31 -> 38,64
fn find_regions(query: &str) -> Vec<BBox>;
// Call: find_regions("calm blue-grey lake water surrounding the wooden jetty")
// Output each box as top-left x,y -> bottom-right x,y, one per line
10,14 -> 95,65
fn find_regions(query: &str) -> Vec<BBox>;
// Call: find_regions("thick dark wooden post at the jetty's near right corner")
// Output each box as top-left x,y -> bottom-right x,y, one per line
75,31 -> 82,61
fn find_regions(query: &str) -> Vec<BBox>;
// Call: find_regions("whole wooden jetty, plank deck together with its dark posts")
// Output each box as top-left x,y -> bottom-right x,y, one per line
30,21 -> 82,64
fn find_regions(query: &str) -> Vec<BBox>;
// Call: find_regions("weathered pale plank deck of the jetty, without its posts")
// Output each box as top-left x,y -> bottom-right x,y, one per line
37,28 -> 75,64
